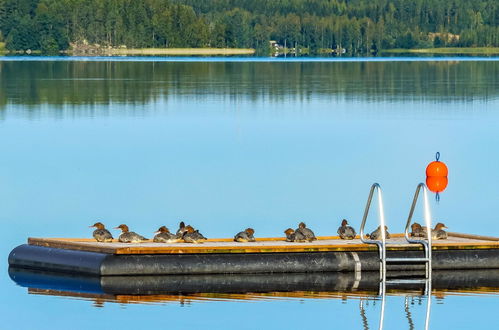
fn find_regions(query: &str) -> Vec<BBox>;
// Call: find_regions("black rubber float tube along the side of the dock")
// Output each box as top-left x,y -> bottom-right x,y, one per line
9,244 -> 499,275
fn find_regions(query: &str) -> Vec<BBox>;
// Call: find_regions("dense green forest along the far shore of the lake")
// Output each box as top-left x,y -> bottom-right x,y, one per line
0,0 -> 499,56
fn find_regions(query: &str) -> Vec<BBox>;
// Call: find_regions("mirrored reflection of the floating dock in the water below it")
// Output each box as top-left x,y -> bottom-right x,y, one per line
9,267 -> 499,306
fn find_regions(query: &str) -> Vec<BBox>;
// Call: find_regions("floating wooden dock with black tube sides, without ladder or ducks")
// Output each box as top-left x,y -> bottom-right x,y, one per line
9,233 -> 499,276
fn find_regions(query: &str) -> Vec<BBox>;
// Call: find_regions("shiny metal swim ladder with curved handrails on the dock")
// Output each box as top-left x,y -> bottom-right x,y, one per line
360,183 -> 432,282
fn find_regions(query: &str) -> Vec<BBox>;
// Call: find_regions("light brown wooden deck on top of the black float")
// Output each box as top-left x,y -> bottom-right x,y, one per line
28,233 -> 499,254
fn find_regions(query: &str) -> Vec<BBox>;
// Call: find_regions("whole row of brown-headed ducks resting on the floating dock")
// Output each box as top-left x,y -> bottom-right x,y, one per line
90,219 -> 447,243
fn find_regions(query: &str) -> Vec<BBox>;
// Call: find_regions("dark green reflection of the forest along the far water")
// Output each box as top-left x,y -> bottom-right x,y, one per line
0,61 -> 499,109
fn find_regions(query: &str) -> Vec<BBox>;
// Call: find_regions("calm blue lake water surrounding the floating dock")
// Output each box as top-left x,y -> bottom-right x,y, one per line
0,58 -> 499,329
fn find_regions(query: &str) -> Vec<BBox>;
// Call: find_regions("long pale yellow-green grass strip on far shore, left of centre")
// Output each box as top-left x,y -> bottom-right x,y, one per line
88,48 -> 255,56
